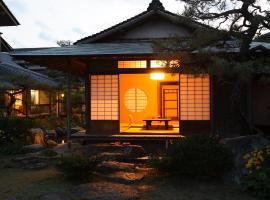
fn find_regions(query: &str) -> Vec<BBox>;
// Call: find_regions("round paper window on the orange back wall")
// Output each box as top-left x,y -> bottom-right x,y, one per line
125,88 -> 147,112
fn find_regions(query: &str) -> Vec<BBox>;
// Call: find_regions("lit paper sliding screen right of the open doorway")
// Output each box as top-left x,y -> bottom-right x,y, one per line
180,74 -> 210,120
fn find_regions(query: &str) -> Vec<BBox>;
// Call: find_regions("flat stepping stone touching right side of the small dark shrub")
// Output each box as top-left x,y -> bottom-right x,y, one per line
97,161 -> 135,174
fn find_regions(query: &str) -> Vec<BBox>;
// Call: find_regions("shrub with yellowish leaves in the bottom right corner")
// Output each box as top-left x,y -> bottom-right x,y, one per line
241,146 -> 270,199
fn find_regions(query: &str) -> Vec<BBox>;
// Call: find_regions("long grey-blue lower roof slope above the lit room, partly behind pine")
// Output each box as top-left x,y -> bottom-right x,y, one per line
11,42 -> 270,58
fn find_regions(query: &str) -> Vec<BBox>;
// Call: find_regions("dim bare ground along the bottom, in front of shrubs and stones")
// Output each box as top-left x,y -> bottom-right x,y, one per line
0,163 -> 256,200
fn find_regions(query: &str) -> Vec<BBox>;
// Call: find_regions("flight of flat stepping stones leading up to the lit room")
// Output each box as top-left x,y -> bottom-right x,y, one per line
94,144 -> 153,184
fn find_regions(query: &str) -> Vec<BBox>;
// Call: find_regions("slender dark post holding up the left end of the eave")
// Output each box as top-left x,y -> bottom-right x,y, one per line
66,72 -> 72,148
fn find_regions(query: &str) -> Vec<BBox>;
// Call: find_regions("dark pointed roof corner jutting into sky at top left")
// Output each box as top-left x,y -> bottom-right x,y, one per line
0,0 -> 20,26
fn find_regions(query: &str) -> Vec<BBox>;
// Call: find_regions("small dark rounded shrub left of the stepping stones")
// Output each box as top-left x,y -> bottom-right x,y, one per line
57,155 -> 99,181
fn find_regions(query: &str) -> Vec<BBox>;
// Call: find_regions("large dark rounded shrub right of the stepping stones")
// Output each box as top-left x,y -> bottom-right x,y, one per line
153,135 -> 233,179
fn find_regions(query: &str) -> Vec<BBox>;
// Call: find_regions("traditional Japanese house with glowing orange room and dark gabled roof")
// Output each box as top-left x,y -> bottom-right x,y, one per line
14,0 -> 270,139
